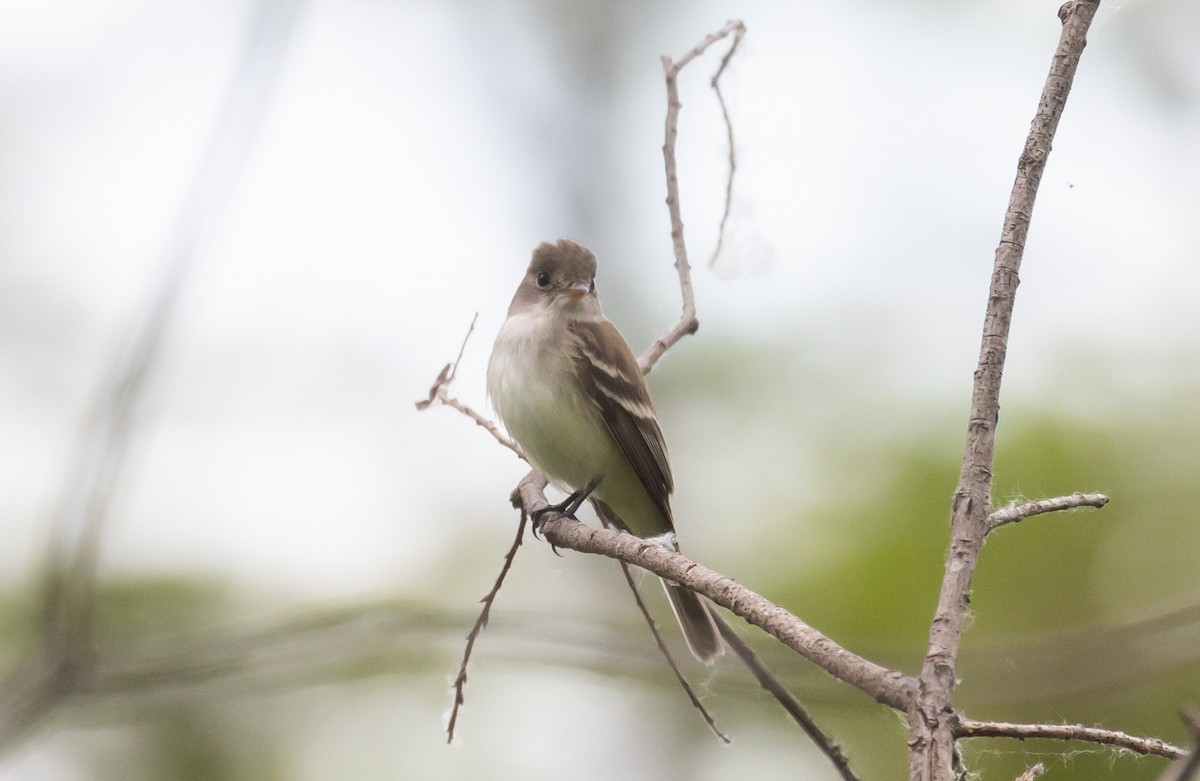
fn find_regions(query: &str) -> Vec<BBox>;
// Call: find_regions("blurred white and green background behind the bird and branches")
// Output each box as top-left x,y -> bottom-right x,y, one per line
0,0 -> 1200,781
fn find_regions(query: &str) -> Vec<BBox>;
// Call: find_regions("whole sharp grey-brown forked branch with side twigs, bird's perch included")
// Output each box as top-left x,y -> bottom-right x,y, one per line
419,7 -> 1180,781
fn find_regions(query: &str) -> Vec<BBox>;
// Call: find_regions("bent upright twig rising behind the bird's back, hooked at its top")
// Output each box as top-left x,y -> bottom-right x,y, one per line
638,19 -> 745,374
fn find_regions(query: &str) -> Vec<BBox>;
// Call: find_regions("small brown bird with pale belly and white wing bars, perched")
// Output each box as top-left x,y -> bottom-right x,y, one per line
487,239 -> 725,663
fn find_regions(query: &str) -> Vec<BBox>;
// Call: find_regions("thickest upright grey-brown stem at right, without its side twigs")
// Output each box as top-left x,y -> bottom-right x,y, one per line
908,0 -> 1099,781
